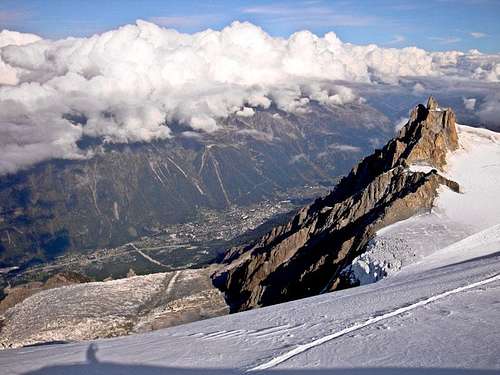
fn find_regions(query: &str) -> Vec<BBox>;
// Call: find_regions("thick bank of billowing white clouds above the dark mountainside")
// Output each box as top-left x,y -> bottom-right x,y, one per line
0,21 -> 500,174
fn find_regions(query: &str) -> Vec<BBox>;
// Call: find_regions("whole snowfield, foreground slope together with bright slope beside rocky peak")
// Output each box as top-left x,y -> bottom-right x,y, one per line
0,127 -> 500,375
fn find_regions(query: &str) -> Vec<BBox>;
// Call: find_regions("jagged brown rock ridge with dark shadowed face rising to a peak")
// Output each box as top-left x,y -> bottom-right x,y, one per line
213,98 -> 459,311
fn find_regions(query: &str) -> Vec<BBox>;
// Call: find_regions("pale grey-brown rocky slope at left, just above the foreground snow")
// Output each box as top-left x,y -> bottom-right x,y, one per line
0,267 -> 228,348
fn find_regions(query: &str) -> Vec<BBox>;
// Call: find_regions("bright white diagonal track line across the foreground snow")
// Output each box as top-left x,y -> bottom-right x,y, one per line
246,274 -> 500,372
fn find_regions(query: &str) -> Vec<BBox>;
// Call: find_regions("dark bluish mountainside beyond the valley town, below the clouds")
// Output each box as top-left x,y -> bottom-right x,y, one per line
0,102 -> 392,267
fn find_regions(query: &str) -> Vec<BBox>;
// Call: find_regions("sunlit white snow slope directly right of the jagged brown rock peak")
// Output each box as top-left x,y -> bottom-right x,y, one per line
343,125 -> 500,285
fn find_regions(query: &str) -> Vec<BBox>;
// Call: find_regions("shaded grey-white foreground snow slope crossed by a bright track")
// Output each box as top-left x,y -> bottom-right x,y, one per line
0,234 -> 500,375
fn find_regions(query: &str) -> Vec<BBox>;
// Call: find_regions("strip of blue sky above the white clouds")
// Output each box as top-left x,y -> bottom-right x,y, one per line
0,0 -> 500,52
